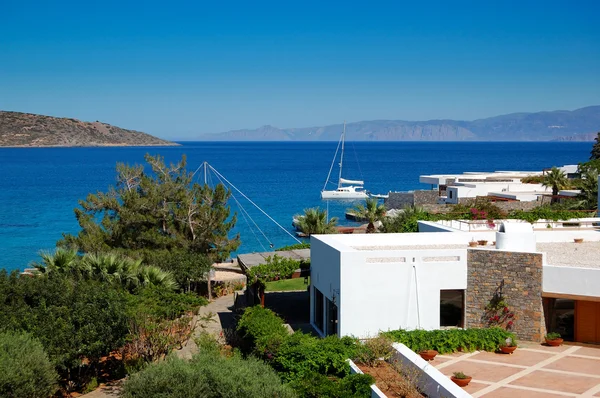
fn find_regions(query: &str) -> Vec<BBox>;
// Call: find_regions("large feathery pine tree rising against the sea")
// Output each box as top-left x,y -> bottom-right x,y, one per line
58,155 -> 240,286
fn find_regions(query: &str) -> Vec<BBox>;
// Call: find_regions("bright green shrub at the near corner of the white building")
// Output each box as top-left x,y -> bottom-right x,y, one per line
272,332 -> 357,381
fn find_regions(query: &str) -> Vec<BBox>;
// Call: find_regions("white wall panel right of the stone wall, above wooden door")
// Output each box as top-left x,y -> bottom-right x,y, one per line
542,265 -> 600,297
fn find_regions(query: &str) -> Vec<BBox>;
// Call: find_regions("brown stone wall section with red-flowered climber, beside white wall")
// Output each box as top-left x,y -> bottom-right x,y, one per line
465,249 -> 546,341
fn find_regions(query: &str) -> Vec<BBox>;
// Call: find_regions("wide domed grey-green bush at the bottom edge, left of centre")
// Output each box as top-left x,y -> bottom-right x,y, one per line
122,352 -> 296,398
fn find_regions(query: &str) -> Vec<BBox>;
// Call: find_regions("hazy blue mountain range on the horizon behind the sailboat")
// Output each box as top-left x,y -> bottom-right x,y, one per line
198,106 -> 600,141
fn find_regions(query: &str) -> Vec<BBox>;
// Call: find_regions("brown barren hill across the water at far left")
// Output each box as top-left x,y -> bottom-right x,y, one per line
0,111 -> 179,147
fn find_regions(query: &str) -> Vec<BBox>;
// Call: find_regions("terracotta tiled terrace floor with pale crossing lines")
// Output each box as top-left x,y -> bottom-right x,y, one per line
431,343 -> 600,398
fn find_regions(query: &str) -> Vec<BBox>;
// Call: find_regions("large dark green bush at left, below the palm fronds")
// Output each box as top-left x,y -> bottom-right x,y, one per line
0,272 -> 127,376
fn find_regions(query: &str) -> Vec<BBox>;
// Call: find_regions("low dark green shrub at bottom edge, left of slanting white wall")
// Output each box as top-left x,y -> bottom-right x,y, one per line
290,372 -> 375,398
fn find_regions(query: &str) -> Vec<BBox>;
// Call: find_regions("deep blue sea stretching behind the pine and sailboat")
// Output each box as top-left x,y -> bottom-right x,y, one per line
0,142 -> 591,269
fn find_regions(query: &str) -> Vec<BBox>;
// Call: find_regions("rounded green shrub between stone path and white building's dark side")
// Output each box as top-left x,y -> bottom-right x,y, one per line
237,305 -> 289,356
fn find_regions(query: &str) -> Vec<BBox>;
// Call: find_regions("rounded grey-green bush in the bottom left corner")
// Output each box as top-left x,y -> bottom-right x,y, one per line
0,332 -> 58,398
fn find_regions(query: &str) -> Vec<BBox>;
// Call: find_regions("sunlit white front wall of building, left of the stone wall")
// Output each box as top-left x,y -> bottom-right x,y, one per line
340,249 -> 467,337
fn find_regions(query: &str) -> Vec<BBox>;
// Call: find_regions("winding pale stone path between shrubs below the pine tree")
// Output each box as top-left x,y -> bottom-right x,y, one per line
82,294 -> 234,398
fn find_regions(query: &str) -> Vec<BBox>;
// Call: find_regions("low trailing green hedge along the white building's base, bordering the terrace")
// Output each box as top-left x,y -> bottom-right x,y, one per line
382,327 -> 516,354
